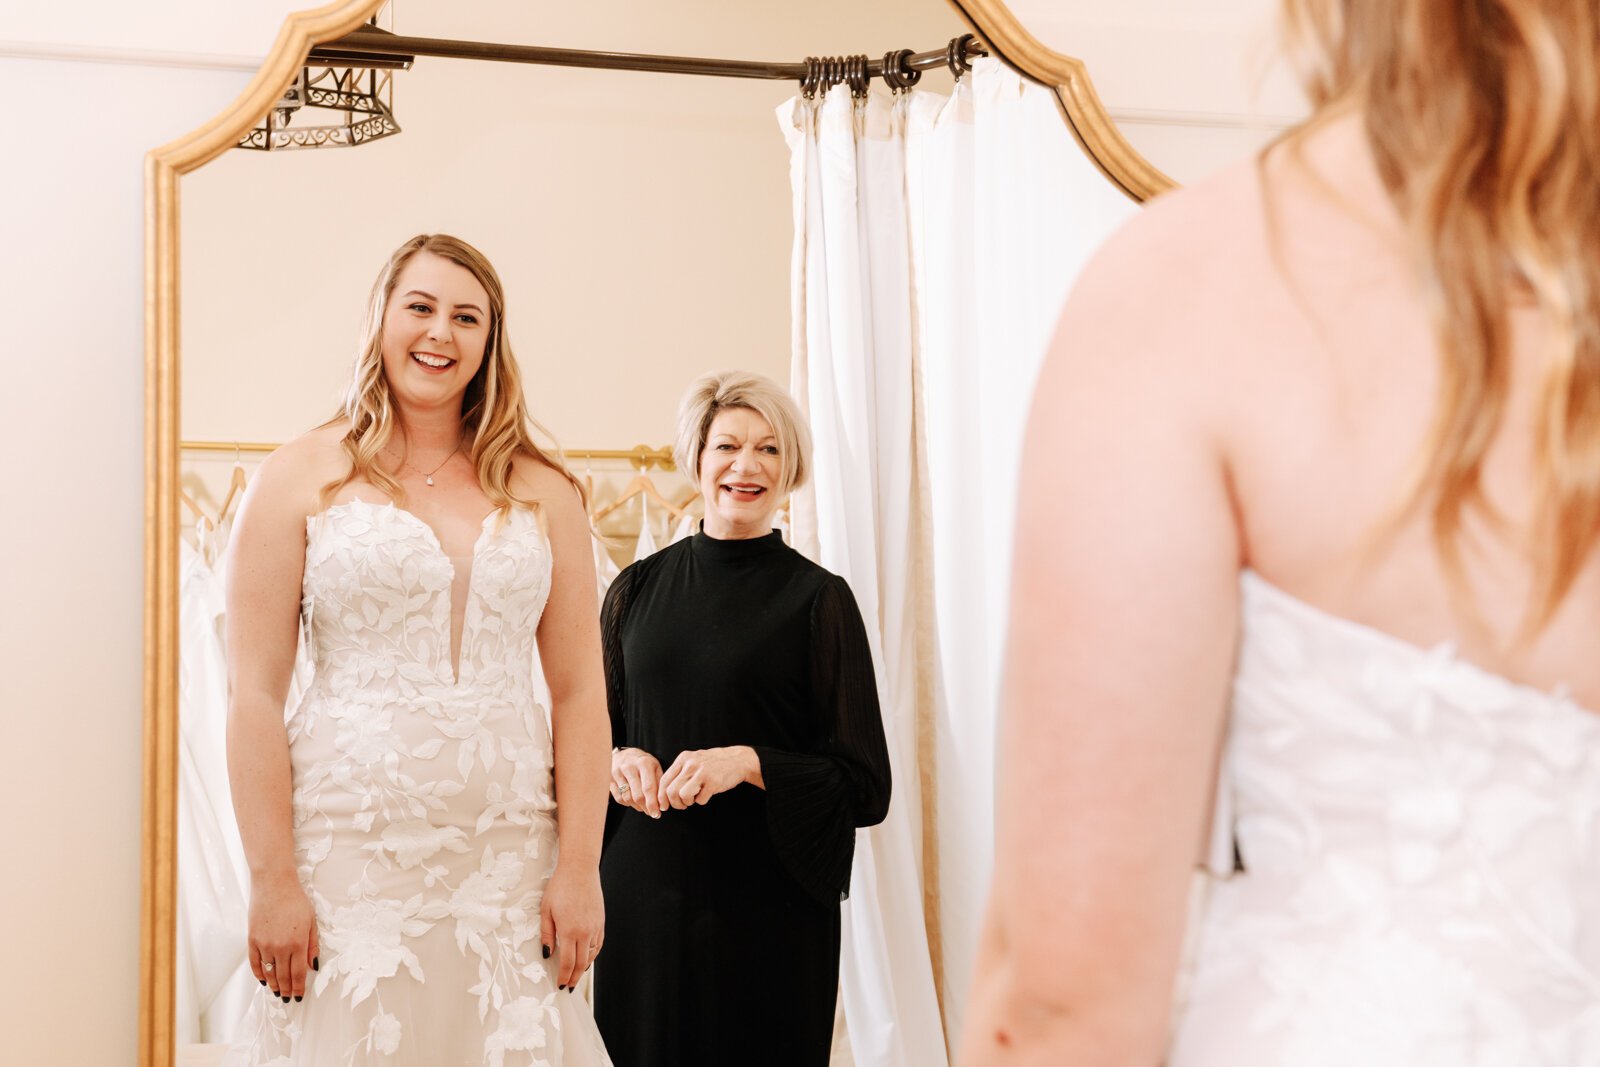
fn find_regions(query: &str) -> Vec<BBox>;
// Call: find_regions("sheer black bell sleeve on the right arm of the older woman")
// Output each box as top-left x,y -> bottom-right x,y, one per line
755,576 -> 890,904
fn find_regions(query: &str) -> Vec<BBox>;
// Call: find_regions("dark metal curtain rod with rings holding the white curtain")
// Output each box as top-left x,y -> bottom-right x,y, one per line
309,27 -> 989,88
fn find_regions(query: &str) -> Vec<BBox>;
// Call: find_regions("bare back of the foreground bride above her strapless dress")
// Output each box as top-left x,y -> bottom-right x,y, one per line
1147,120 -> 1600,709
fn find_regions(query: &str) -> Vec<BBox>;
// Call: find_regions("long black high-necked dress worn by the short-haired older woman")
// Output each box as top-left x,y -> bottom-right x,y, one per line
595,533 -> 890,1067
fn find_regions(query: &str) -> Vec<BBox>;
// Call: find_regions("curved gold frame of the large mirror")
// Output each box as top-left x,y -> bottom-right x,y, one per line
139,0 -> 1174,1067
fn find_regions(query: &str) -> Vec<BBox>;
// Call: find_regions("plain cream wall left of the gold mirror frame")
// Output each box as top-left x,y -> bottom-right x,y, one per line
0,0 -> 299,1067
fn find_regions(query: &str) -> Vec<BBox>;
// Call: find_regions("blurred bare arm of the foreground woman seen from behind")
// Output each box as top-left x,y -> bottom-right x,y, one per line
960,223 -> 1240,1067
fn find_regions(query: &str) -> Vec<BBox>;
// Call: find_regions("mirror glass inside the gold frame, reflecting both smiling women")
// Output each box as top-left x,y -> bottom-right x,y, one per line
176,2 -> 1134,1065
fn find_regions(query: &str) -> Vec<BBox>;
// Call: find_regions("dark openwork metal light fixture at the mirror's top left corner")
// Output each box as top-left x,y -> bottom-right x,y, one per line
237,27 -> 413,152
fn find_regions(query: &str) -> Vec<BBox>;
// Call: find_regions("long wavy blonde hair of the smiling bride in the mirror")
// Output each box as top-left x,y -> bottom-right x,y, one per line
322,234 -> 587,512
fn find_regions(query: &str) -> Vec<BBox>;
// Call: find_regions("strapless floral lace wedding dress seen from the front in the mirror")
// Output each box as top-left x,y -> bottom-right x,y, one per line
232,501 -> 610,1067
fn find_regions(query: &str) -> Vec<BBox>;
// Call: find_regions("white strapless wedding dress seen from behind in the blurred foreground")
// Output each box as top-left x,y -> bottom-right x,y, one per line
1168,574 -> 1600,1067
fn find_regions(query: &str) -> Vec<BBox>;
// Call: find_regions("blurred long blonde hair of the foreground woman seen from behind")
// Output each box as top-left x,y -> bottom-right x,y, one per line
1285,0 -> 1600,633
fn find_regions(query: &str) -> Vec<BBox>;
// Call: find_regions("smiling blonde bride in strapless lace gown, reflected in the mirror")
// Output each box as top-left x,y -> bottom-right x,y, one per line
227,234 -> 610,1067
